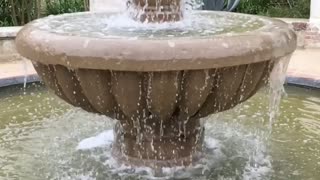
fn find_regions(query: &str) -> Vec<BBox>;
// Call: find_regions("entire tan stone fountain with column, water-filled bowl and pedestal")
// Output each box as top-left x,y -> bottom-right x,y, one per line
16,0 -> 296,168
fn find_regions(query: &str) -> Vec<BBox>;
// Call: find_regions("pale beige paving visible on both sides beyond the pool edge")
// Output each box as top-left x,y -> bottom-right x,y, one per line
0,49 -> 320,88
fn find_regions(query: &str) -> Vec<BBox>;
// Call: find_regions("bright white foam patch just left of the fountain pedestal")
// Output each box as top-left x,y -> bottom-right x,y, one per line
76,130 -> 114,150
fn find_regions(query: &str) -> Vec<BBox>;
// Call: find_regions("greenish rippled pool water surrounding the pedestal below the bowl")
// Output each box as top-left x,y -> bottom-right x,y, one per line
0,84 -> 320,180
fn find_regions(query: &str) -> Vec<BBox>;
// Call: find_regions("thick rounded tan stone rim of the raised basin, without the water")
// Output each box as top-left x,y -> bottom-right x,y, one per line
16,11 -> 297,72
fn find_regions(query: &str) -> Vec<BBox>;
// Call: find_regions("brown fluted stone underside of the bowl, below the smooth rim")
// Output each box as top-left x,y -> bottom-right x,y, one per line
34,60 -> 275,124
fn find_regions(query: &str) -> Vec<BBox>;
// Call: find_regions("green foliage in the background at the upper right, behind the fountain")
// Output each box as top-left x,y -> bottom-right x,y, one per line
236,0 -> 310,18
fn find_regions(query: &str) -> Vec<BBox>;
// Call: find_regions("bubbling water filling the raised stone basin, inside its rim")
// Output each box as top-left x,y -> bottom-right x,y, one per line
33,11 -> 270,40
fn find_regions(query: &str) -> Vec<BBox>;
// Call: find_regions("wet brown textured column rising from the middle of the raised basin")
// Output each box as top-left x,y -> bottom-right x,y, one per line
128,0 -> 182,22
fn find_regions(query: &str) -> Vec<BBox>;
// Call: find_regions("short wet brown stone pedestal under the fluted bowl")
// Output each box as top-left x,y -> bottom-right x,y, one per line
112,120 -> 204,169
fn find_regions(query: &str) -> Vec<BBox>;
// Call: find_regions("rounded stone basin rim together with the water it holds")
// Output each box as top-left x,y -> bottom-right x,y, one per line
17,11 -> 296,72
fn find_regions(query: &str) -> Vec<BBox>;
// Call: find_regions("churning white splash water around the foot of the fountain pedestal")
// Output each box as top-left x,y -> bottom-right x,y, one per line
72,116 -> 272,179
